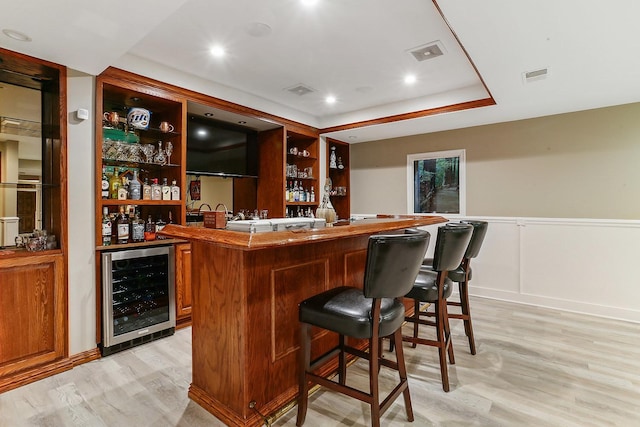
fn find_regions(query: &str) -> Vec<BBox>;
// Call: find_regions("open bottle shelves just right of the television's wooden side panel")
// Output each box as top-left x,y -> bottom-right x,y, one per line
285,131 -> 319,217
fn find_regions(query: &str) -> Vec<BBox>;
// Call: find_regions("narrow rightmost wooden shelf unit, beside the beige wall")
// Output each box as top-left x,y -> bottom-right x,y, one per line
327,138 -> 351,220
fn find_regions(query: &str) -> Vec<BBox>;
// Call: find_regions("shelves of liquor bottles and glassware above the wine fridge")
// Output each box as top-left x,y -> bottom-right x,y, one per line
96,73 -> 186,250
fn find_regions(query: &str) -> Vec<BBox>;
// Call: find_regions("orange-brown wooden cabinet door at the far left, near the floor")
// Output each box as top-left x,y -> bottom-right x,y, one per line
0,254 -> 67,386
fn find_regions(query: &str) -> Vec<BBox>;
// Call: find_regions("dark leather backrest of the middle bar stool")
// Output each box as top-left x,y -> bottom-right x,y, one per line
433,223 -> 473,271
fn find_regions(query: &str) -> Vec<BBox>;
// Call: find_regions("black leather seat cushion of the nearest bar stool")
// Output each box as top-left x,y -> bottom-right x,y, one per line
299,286 -> 404,338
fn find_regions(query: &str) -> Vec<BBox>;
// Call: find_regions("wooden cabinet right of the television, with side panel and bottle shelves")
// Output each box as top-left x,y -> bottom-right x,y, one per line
257,126 -> 320,218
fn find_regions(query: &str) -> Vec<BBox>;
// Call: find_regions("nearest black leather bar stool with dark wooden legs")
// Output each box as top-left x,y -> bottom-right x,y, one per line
296,230 -> 430,427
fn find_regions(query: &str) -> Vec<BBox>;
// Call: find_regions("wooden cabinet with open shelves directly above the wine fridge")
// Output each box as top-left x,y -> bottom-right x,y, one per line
95,68 -> 186,246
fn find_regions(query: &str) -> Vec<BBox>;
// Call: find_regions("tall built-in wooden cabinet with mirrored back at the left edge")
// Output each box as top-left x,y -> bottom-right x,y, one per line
0,49 -> 72,393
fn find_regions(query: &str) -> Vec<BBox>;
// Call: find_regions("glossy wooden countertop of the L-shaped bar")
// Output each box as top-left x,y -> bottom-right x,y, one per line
162,215 -> 447,250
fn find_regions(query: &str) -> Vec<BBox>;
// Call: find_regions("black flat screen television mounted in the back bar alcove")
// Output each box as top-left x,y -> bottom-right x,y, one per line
187,115 -> 258,178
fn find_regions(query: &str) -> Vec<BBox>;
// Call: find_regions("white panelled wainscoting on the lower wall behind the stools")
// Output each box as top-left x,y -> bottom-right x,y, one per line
352,217 -> 640,323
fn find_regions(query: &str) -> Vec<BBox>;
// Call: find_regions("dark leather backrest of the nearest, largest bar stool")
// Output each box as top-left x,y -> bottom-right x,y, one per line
364,230 -> 431,298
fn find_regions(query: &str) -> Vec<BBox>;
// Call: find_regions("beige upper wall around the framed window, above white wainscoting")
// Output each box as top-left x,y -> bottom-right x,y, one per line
351,103 -> 640,219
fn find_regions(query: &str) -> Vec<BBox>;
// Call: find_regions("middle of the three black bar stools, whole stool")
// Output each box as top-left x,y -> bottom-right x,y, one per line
402,223 -> 473,391
